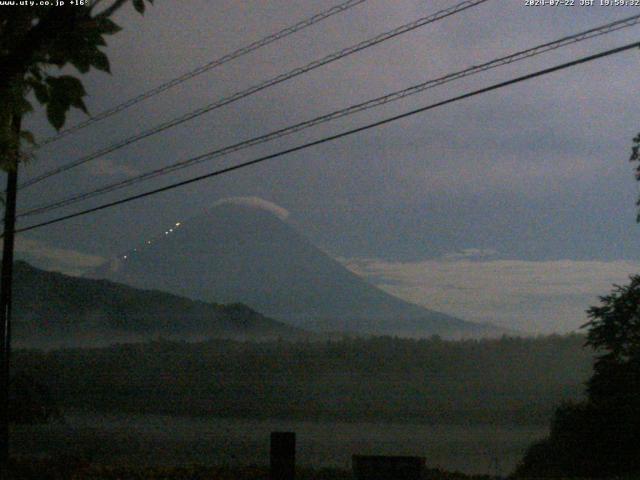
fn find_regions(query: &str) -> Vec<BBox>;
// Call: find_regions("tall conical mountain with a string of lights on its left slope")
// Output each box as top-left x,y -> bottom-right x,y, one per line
91,202 -> 501,337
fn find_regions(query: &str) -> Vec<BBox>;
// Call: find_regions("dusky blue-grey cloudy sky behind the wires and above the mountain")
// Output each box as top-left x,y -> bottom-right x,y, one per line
10,0 -> 640,333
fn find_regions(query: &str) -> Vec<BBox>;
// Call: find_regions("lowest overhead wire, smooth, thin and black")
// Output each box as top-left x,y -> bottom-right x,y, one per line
15,42 -> 640,233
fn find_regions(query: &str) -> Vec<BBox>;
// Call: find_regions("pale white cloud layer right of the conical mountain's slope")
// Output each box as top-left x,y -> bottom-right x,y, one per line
341,255 -> 640,333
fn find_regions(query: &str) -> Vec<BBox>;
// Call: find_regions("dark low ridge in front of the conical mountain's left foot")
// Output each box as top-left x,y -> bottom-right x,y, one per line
13,262 -> 307,348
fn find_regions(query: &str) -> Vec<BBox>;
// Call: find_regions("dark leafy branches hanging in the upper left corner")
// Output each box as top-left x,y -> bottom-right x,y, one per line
0,0 -> 153,170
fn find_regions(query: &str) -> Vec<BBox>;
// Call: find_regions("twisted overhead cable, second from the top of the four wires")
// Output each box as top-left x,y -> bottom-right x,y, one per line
18,0 -> 488,189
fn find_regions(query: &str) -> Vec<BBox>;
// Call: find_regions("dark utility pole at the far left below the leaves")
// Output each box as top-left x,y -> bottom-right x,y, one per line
0,115 -> 21,470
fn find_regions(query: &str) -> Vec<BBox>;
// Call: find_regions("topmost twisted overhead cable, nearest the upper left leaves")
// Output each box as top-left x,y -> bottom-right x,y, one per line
36,0 -> 367,148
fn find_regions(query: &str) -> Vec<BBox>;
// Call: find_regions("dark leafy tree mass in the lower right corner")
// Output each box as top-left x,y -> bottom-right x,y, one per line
518,276 -> 640,478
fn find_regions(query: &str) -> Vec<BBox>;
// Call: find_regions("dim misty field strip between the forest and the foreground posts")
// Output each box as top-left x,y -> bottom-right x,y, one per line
13,413 -> 547,474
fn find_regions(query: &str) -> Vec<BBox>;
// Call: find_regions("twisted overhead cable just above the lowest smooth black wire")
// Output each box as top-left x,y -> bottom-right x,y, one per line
18,14 -> 640,217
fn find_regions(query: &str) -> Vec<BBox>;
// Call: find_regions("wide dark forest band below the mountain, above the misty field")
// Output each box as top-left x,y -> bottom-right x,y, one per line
14,335 -> 592,424
